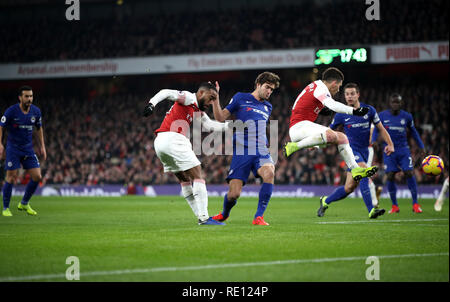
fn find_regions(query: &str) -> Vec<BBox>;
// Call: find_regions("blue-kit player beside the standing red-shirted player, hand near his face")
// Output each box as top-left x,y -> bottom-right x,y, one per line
213,72 -> 280,225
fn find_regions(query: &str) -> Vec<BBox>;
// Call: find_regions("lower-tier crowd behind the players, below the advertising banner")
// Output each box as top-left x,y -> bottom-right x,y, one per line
0,78 -> 449,185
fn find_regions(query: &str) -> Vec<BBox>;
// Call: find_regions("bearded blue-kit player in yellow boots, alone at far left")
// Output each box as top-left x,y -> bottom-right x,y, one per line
0,86 -> 47,216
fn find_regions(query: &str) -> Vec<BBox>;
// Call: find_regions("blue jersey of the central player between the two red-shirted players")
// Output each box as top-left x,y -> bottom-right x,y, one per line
225,92 -> 272,154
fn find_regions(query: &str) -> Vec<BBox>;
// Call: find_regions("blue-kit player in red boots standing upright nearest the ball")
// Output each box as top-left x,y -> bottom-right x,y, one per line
372,93 -> 425,214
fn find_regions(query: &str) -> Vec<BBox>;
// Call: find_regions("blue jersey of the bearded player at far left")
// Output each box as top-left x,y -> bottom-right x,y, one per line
0,104 -> 42,151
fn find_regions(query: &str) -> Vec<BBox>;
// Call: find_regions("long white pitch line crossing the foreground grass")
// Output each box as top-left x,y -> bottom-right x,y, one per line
0,252 -> 449,282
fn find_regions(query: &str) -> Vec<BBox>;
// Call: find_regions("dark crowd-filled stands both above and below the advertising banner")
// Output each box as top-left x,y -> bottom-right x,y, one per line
0,0 -> 449,191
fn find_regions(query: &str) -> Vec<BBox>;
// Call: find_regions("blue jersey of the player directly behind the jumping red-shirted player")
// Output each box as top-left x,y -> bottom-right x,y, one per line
330,103 -> 380,149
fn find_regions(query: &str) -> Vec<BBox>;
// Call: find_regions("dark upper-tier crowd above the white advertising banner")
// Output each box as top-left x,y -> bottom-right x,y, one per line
0,0 -> 449,63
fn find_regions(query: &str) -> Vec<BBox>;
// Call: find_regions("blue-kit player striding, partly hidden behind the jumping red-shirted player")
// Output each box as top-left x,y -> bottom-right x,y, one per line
317,83 -> 394,219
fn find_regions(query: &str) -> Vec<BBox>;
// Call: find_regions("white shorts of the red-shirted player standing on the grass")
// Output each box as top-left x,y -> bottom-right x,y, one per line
153,131 -> 200,173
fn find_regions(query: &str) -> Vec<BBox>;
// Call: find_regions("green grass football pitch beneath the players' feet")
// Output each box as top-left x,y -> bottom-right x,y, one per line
0,196 -> 449,282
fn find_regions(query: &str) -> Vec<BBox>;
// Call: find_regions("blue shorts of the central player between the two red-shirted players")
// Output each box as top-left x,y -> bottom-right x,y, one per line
227,154 -> 274,185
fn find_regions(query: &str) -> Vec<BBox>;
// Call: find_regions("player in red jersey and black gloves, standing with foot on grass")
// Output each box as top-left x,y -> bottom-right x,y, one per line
144,83 -> 227,225
